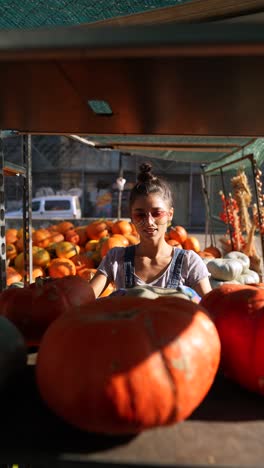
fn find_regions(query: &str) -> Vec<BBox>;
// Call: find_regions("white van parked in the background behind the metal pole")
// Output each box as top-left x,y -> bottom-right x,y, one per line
5,195 -> 82,219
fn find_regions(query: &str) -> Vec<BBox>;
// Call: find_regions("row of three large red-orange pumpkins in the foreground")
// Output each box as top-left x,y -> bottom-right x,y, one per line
0,276 -> 264,434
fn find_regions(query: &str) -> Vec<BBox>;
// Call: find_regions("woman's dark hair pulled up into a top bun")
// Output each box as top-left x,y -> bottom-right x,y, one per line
129,163 -> 173,208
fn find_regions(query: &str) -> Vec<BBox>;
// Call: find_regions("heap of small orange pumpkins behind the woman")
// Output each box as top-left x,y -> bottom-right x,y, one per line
6,219 -> 200,288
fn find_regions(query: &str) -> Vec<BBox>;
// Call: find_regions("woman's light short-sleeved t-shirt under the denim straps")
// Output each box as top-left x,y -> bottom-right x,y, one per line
97,247 -> 210,289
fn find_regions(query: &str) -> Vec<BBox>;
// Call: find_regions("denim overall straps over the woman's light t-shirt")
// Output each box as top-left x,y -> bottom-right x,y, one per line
124,245 -> 185,289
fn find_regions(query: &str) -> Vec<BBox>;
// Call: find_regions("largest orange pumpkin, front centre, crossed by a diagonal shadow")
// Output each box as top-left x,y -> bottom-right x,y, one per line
36,296 -> 220,434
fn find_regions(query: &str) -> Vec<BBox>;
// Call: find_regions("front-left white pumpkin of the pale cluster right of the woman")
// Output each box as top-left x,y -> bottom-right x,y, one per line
207,258 -> 244,281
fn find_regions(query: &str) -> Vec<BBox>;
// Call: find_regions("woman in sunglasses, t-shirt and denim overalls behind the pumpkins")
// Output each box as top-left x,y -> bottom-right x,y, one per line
90,164 -> 211,297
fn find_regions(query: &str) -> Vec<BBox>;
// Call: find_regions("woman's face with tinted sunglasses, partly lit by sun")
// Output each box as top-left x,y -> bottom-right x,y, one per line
131,194 -> 173,239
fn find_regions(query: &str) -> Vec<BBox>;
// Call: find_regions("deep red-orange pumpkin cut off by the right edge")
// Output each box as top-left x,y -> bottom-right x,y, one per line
201,284 -> 264,395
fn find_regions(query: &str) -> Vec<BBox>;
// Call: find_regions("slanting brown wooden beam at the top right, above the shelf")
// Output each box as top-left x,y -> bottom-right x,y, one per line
86,0 -> 264,28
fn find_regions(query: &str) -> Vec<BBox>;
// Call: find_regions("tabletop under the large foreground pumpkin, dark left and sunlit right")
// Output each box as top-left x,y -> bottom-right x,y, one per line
0,365 -> 264,467
